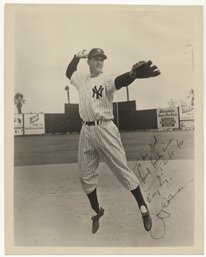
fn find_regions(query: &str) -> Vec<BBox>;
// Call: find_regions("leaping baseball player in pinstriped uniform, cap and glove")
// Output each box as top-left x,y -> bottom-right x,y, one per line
66,48 -> 160,233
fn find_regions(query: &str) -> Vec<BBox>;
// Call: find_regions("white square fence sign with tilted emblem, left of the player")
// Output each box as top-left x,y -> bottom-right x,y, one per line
24,113 -> 45,135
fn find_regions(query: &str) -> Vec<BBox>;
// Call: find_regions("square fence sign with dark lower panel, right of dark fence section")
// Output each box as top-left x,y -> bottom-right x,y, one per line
157,107 -> 179,129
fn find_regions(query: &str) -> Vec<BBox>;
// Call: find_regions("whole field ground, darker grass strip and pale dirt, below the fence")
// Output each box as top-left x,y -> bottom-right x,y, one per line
14,131 -> 194,247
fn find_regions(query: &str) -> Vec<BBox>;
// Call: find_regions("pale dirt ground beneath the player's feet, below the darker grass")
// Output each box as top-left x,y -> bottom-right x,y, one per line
14,160 -> 194,247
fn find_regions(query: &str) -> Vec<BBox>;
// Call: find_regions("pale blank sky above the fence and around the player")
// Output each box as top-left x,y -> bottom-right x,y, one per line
14,5 -> 200,113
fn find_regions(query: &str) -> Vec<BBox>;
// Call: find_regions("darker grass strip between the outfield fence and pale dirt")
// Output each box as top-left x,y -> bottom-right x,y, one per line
14,130 -> 194,166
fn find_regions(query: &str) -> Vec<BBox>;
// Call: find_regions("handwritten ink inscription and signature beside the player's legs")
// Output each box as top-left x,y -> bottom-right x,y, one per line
133,136 -> 193,239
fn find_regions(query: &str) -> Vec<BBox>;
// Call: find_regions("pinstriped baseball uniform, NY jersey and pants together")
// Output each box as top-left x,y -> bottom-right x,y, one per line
70,71 -> 139,194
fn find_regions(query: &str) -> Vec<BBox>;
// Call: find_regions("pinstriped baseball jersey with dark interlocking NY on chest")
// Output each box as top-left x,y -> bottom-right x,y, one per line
70,71 -> 116,121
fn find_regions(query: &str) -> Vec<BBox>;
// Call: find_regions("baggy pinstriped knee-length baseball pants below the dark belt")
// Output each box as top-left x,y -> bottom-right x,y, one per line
78,121 -> 140,194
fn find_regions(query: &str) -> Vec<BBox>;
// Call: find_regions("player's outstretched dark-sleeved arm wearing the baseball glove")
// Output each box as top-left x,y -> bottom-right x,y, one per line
115,61 -> 160,89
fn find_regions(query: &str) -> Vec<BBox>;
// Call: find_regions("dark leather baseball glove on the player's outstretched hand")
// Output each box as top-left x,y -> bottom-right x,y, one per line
130,61 -> 161,79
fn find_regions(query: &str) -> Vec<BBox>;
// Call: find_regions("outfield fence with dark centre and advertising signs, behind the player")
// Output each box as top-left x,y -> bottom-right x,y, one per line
14,101 -> 194,135
